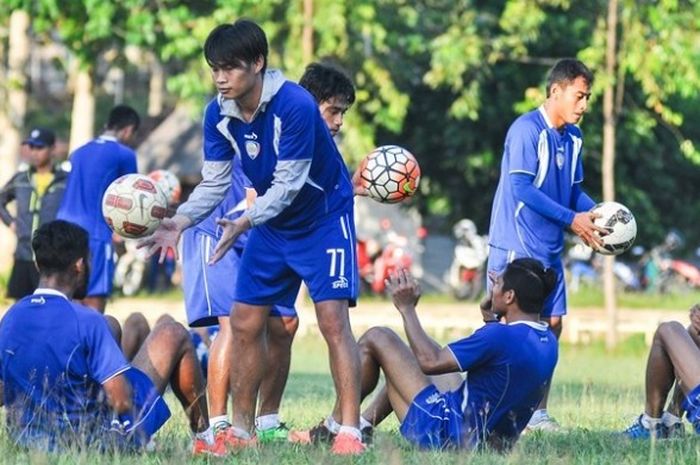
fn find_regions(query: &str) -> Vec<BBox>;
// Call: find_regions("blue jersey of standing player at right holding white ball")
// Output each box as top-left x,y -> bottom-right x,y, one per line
489,107 -> 583,265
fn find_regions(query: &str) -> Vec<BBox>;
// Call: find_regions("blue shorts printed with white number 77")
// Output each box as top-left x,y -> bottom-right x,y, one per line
236,212 -> 359,307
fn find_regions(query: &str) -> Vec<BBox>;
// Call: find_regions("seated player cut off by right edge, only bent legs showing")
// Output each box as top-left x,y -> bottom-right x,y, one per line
623,304 -> 700,439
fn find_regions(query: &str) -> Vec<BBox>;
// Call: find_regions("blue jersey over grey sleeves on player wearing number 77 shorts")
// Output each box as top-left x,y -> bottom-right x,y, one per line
204,71 -> 353,231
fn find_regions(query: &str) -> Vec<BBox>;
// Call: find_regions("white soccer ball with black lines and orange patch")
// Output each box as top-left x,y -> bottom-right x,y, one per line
360,145 -> 420,203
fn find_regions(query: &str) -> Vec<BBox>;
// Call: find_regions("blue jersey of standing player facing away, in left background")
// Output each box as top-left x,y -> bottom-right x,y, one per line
57,136 -> 136,242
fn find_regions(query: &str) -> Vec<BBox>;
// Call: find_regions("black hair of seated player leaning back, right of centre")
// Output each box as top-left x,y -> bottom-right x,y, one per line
503,258 -> 557,313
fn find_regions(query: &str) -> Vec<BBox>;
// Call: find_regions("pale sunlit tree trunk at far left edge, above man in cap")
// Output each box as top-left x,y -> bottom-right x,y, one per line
0,10 -> 31,271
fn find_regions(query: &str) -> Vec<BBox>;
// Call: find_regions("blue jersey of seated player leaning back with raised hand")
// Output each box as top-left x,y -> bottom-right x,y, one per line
448,322 -> 558,442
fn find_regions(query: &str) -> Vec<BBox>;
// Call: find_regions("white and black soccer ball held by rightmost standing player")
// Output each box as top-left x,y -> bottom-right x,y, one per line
591,202 -> 637,255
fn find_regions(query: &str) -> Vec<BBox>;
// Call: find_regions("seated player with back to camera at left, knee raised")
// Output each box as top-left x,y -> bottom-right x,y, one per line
0,220 -> 221,454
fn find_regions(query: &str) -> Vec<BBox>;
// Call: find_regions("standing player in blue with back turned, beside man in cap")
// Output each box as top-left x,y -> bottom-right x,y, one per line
57,105 -> 141,313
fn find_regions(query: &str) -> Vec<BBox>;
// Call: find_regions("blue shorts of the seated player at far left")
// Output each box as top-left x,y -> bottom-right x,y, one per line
108,368 -> 170,450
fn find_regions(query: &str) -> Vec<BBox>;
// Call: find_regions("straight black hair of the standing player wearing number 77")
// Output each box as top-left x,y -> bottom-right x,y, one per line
204,19 -> 268,73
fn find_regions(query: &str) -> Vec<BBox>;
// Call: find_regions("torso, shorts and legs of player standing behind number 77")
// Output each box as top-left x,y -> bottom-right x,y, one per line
182,158 -> 299,444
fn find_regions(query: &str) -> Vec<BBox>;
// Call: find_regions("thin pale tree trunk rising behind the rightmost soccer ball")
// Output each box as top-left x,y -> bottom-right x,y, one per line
602,0 -> 618,350
